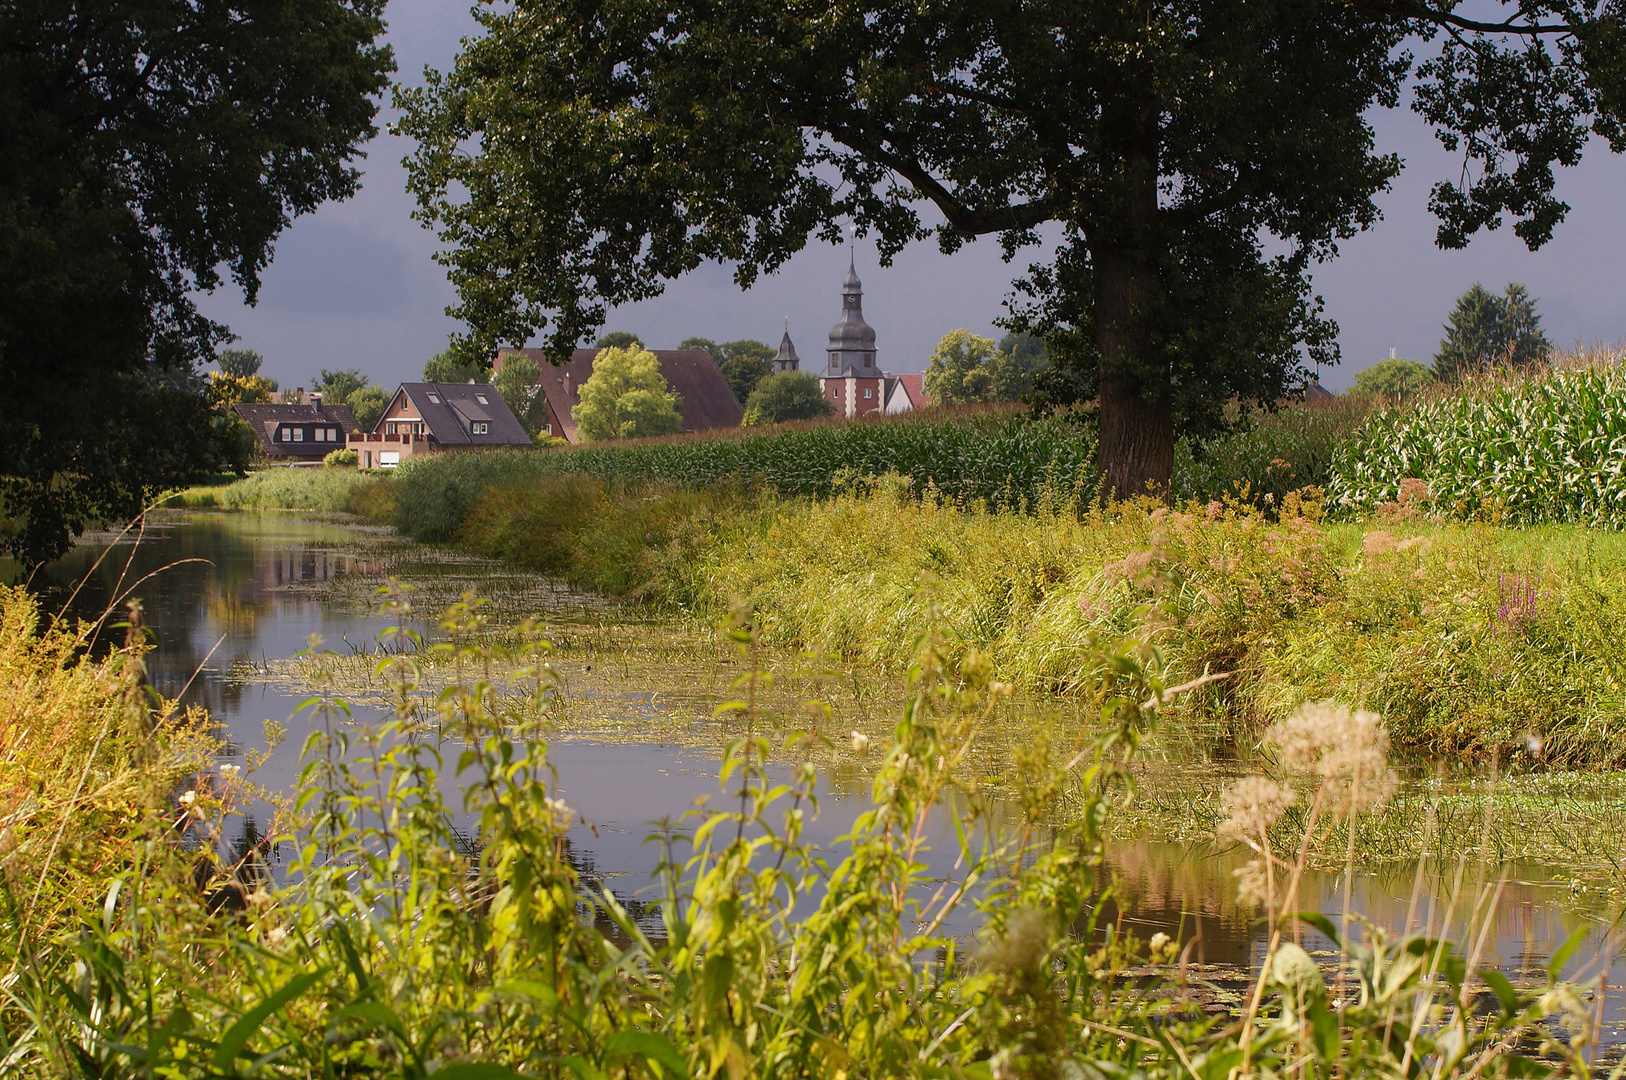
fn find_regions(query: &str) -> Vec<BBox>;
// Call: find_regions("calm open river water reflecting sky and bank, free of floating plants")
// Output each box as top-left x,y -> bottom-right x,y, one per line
15,512 -> 1626,1041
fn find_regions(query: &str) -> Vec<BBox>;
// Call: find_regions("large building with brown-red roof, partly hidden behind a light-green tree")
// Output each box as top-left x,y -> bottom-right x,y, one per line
493,348 -> 745,442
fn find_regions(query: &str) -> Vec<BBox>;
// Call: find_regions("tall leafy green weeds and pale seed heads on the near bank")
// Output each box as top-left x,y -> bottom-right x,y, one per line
0,592 -> 1593,1080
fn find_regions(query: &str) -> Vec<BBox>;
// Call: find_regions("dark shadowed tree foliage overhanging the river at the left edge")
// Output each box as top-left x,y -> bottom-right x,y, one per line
0,0 -> 393,563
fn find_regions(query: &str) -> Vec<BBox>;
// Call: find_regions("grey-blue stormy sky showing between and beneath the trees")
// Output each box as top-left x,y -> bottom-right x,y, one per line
203,0 -> 1626,389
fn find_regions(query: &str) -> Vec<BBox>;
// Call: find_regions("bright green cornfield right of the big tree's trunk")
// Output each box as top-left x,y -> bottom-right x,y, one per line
1327,364 -> 1626,529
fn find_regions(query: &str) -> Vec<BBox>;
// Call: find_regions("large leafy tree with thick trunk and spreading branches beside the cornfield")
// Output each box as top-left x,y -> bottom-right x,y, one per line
400,0 -> 1626,494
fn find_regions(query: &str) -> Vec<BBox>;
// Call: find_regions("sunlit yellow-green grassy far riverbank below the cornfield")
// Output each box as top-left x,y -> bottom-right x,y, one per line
186,455 -> 1626,768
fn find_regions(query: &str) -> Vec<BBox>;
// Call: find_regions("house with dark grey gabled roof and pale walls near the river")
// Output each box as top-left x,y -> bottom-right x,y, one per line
350,382 -> 532,468
